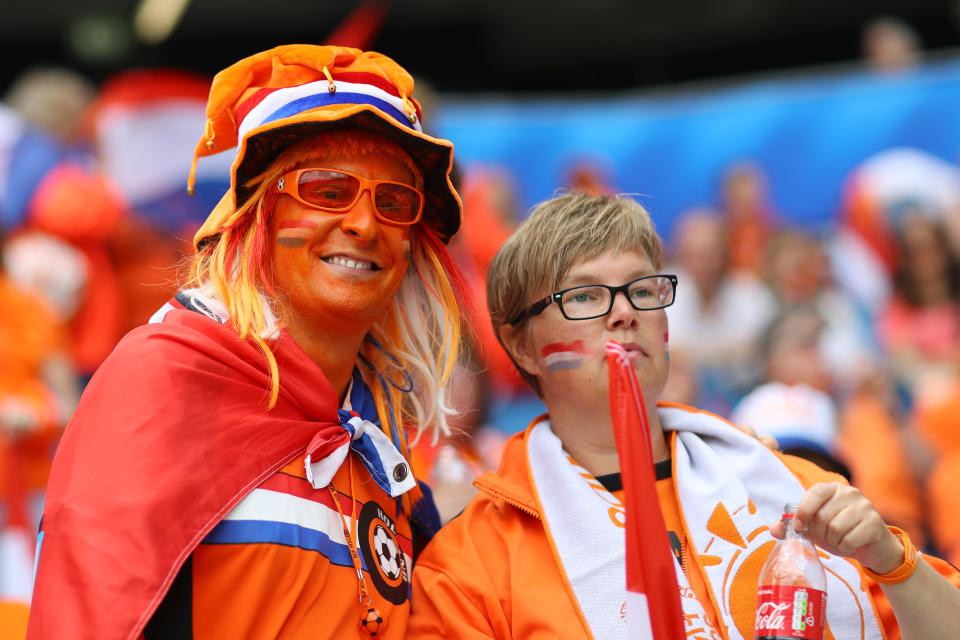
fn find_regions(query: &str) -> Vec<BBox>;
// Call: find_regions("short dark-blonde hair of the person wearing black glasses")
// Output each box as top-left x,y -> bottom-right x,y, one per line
487,193 -> 663,394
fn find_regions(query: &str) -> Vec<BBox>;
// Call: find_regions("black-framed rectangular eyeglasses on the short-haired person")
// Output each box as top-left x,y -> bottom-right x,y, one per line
511,274 -> 677,324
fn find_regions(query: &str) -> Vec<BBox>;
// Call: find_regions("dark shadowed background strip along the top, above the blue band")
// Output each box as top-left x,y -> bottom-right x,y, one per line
0,0 -> 960,94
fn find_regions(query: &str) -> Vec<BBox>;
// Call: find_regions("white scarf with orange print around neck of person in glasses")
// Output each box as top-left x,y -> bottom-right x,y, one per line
527,407 -> 885,640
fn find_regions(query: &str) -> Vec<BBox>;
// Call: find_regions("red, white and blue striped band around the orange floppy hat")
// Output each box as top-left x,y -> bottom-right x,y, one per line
236,79 -> 423,140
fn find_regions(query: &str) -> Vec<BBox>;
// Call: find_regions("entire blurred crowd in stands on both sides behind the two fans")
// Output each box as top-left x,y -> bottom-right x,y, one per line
0,15 -> 960,621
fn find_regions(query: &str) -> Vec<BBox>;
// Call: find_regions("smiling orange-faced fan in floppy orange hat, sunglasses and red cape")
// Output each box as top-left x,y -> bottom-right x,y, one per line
28,45 -> 461,639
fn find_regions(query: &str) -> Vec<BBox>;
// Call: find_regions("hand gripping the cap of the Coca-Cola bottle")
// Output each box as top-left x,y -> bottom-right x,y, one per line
770,482 -> 904,574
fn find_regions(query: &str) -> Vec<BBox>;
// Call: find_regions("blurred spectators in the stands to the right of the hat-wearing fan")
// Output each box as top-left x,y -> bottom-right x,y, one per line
432,142 -> 960,563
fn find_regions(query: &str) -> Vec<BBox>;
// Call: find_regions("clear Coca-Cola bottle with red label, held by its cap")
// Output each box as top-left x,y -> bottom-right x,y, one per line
753,503 -> 827,640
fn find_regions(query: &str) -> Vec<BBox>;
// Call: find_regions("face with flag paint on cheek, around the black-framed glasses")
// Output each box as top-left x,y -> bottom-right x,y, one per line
509,250 -> 669,413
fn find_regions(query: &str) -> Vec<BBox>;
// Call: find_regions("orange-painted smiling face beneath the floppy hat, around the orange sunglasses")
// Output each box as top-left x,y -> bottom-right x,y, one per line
269,153 -> 414,337
